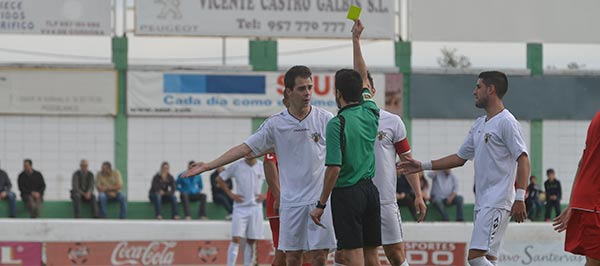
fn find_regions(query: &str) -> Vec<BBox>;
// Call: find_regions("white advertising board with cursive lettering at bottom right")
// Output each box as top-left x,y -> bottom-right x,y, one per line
498,241 -> 585,266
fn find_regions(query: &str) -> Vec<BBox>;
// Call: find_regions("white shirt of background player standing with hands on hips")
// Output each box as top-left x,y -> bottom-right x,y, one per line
219,159 -> 265,208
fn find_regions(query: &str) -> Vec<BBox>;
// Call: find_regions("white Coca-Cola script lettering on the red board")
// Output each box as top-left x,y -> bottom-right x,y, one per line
110,241 -> 177,265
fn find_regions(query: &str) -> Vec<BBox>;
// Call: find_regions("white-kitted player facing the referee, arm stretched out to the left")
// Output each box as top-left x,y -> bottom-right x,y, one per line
185,66 -> 336,266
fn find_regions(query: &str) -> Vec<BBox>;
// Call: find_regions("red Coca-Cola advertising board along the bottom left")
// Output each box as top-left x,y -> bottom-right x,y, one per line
46,240 -> 273,266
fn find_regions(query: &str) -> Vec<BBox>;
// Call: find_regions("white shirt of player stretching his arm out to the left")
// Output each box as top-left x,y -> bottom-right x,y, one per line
244,106 -> 333,207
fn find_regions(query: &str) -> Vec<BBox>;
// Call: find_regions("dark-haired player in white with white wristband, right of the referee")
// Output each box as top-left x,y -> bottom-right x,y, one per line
399,71 -> 530,266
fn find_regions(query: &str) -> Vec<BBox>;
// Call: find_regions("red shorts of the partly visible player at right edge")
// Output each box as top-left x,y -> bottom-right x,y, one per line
565,209 -> 600,260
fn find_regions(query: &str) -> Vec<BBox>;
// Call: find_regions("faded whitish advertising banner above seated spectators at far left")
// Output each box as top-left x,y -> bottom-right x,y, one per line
0,69 -> 117,115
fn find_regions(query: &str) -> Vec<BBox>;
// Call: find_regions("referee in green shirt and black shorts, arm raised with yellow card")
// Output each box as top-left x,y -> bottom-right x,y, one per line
311,21 -> 381,265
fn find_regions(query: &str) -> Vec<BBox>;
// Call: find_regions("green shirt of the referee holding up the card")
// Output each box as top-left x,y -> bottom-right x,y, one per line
325,89 -> 379,187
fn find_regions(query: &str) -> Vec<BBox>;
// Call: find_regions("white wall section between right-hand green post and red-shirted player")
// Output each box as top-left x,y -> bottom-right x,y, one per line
538,120 -> 590,203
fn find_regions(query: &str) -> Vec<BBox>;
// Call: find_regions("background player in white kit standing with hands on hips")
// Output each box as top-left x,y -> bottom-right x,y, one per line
217,157 -> 267,266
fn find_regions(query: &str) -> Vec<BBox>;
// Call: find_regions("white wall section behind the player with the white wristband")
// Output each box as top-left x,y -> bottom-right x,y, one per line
412,119 -> 530,203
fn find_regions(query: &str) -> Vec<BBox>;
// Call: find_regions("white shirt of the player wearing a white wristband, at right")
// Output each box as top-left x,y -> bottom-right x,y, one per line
457,109 -> 528,211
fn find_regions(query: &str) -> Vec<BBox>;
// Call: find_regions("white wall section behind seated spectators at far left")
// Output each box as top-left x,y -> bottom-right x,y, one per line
0,115 -> 114,200
